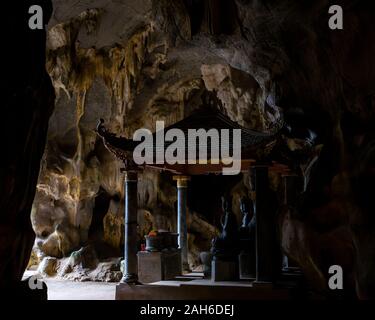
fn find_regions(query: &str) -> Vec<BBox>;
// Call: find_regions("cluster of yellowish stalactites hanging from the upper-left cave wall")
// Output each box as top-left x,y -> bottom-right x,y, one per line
47,15 -> 153,128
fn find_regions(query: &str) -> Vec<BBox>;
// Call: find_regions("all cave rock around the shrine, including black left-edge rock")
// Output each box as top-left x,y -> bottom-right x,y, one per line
0,0 -> 375,297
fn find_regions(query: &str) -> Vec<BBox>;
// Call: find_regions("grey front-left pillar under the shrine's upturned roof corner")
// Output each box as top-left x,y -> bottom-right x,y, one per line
121,171 -> 138,284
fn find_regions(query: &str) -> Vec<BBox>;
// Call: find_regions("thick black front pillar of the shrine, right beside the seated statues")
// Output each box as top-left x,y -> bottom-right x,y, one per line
252,166 -> 275,283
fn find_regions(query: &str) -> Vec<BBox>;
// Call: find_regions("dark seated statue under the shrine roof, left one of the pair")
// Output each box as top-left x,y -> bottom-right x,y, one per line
211,197 -> 239,260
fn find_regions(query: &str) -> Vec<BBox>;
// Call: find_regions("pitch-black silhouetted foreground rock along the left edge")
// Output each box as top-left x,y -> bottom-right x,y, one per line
0,1 -> 54,295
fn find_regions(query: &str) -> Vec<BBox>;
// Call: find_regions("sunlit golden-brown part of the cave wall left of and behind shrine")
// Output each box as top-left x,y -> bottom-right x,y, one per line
32,1 -> 280,272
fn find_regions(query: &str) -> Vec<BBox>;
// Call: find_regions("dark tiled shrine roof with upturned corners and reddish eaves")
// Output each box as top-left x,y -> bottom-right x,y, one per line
96,108 -> 289,176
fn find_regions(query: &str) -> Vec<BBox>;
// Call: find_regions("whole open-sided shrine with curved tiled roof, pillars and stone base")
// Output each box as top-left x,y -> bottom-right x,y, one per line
97,106 -> 296,299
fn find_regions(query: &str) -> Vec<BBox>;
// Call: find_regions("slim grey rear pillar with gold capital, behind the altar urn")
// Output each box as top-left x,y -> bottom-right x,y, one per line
174,176 -> 190,271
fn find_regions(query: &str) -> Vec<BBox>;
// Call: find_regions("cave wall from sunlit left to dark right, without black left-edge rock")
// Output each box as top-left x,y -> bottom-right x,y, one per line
25,0 -> 375,296
